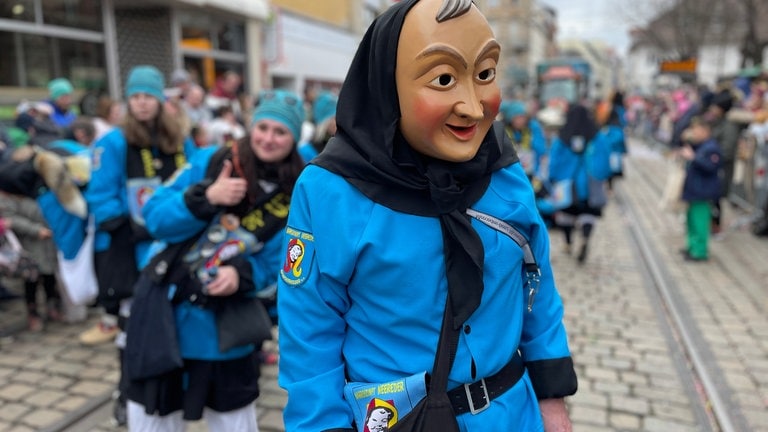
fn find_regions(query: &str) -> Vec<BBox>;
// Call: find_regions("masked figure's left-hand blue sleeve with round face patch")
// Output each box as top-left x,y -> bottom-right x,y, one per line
277,165 -> 365,432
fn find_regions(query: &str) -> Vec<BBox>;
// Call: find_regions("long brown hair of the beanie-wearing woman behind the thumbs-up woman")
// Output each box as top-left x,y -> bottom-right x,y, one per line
122,102 -> 184,154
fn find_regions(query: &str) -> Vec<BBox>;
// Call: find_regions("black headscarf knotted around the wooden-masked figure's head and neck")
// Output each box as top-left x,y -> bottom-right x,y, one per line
312,0 -> 517,328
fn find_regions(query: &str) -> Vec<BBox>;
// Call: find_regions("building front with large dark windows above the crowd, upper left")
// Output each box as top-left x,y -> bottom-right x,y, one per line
0,0 -> 270,118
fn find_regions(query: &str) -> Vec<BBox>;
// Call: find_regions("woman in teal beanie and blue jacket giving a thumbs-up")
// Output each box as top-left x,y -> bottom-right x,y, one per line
127,90 -> 304,432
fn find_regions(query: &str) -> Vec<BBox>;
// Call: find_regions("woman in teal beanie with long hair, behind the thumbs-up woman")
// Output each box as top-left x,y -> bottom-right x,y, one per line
80,65 -> 194,424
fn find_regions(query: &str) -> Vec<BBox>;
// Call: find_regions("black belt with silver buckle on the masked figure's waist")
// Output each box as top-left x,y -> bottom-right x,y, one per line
448,353 -> 525,415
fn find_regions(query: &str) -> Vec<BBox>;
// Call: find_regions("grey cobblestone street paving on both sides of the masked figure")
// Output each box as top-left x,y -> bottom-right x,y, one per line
0,136 -> 768,432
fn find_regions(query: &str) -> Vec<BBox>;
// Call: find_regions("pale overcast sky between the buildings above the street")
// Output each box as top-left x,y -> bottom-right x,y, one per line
540,0 -> 644,55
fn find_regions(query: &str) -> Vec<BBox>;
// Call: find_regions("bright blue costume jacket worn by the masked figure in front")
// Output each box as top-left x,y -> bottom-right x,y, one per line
278,164 -> 570,432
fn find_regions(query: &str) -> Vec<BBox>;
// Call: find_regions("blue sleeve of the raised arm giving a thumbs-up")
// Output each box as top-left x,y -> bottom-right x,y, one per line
142,148 -> 216,243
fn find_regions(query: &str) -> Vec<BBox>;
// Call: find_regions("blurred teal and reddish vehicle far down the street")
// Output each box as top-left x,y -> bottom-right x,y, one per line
536,57 -> 591,107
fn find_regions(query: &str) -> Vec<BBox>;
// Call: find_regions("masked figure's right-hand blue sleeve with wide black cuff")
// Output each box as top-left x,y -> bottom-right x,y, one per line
520,201 -> 577,399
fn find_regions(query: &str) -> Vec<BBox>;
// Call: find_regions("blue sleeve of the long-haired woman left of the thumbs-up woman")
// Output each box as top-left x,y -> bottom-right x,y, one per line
84,129 -> 128,231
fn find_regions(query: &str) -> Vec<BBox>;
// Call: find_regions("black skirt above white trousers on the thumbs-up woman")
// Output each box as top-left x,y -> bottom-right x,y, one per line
128,353 -> 260,420
